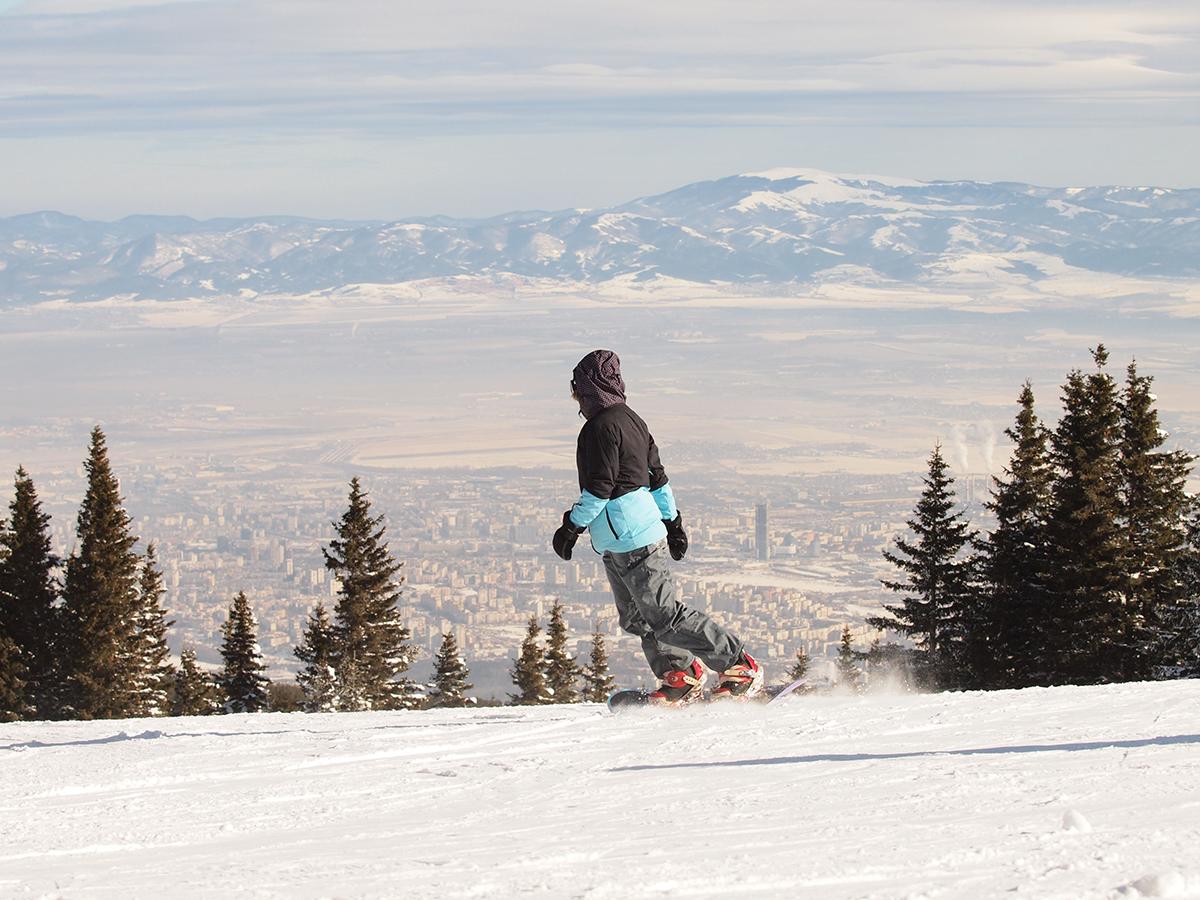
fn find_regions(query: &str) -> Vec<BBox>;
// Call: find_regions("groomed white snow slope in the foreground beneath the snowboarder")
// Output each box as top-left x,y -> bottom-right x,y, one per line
0,682 -> 1200,900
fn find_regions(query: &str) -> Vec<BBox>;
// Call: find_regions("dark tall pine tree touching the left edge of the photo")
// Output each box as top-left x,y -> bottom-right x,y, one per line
0,468 -> 61,719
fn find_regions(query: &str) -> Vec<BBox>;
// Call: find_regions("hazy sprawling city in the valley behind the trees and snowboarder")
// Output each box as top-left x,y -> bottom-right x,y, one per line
21,451 -> 936,698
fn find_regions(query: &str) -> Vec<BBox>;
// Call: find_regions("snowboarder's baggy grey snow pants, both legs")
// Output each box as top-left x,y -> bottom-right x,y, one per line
604,540 -> 742,678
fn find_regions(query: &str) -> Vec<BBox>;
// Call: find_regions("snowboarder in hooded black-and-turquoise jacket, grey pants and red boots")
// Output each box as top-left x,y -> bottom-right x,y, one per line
553,350 -> 763,706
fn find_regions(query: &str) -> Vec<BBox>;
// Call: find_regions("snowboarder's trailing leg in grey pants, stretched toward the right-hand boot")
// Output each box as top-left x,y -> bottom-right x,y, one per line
605,541 -> 742,673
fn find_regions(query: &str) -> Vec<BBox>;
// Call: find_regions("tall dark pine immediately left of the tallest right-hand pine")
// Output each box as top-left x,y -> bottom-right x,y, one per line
964,382 -> 1054,689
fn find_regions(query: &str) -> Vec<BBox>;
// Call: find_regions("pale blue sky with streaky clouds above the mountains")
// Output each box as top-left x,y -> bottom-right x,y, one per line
0,0 -> 1200,218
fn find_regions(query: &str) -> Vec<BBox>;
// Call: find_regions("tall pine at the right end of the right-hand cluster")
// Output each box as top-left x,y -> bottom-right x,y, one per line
1121,361 -> 1194,679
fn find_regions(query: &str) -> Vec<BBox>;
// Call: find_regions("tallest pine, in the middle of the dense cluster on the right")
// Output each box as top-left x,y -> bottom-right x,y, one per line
1042,344 -> 1135,684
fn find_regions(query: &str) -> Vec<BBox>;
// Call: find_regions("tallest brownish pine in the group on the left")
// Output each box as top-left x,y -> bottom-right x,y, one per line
60,426 -> 138,719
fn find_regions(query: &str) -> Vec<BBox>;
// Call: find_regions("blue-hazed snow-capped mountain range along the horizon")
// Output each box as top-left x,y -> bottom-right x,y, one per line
0,169 -> 1200,302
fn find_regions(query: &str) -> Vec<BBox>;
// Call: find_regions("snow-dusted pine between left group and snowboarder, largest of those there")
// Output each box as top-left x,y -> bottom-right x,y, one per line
323,478 -> 416,709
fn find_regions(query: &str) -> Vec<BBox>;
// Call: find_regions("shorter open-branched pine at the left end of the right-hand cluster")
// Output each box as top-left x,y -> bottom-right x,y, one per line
866,446 -> 976,686
